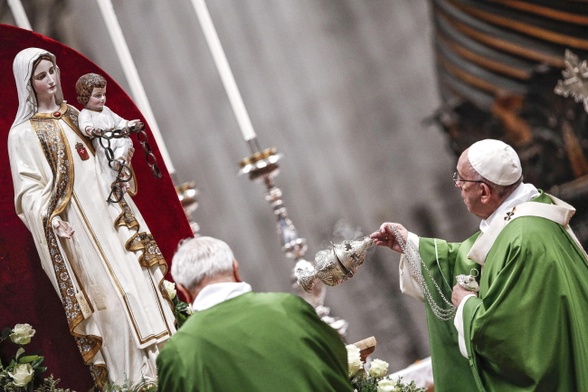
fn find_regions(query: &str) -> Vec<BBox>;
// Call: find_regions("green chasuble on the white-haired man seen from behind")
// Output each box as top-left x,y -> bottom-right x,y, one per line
157,292 -> 352,392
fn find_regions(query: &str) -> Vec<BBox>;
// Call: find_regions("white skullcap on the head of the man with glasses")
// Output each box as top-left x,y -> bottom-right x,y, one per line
468,139 -> 523,186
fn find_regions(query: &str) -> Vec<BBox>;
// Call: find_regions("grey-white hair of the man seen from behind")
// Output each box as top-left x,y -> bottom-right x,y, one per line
171,236 -> 235,290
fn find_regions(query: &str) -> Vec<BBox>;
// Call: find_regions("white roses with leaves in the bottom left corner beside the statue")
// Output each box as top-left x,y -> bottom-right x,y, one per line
0,324 -> 69,392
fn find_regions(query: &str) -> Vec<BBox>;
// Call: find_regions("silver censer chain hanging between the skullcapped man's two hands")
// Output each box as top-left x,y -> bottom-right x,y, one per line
389,225 -> 457,321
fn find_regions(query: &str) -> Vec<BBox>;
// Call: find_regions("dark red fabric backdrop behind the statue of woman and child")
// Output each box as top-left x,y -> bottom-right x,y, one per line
0,25 -> 192,391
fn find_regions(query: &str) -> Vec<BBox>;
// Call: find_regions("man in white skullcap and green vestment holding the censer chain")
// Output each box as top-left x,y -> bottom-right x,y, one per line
371,139 -> 588,392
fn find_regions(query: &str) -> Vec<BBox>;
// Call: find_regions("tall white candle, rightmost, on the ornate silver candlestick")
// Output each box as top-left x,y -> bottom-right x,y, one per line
192,0 -> 256,141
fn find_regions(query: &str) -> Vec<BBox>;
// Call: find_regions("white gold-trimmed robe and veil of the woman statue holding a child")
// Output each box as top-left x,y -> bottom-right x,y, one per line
8,48 -> 175,386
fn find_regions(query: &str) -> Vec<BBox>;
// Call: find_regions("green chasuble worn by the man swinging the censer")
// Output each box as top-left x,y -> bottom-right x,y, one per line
420,193 -> 588,392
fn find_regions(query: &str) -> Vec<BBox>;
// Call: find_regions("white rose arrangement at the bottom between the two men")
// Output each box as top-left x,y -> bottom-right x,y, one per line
345,344 -> 426,392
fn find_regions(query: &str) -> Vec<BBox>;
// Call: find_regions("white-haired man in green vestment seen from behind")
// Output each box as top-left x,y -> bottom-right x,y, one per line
157,237 -> 353,392
